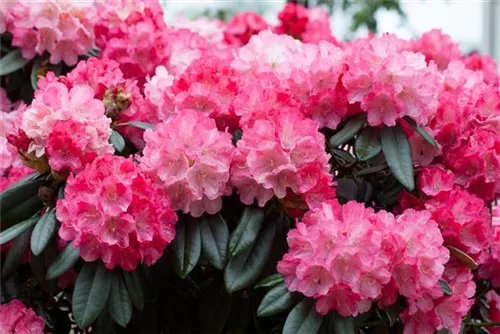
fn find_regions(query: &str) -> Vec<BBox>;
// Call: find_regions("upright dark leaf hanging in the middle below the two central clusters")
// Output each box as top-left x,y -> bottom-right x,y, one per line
200,214 -> 229,270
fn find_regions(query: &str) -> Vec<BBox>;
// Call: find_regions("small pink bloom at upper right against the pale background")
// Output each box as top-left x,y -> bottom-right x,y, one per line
411,29 -> 462,70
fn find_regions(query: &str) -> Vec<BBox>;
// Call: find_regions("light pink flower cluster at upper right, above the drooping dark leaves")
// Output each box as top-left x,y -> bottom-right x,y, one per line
342,35 -> 442,126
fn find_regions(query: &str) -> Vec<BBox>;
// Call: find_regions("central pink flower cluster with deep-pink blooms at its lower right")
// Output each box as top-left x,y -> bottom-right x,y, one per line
231,110 -> 335,206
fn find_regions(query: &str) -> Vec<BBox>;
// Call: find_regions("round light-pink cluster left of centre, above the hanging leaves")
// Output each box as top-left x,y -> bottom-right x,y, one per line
139,109 -> 234,217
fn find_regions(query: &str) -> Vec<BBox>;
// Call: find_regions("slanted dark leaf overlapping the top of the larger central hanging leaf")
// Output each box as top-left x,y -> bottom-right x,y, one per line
229,206 -> 264,257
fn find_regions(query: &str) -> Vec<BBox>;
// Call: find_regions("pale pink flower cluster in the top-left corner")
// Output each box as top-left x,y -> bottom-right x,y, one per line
0,0 -> 98,66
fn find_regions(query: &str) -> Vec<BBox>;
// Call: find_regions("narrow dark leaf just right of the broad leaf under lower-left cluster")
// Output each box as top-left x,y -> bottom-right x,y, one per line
107,270 -> 132,327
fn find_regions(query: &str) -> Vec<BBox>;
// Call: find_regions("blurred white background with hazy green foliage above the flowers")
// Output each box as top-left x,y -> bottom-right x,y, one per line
162,0 -> 500,61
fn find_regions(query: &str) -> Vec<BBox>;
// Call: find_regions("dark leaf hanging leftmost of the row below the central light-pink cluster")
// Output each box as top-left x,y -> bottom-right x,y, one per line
171,219 -> 201,278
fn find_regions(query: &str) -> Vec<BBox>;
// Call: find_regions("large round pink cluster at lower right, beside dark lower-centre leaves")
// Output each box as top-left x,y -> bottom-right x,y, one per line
278,200 -> 394,316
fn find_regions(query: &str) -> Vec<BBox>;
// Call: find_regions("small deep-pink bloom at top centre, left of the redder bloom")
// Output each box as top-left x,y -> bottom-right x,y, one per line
224,12 -> 268,46
